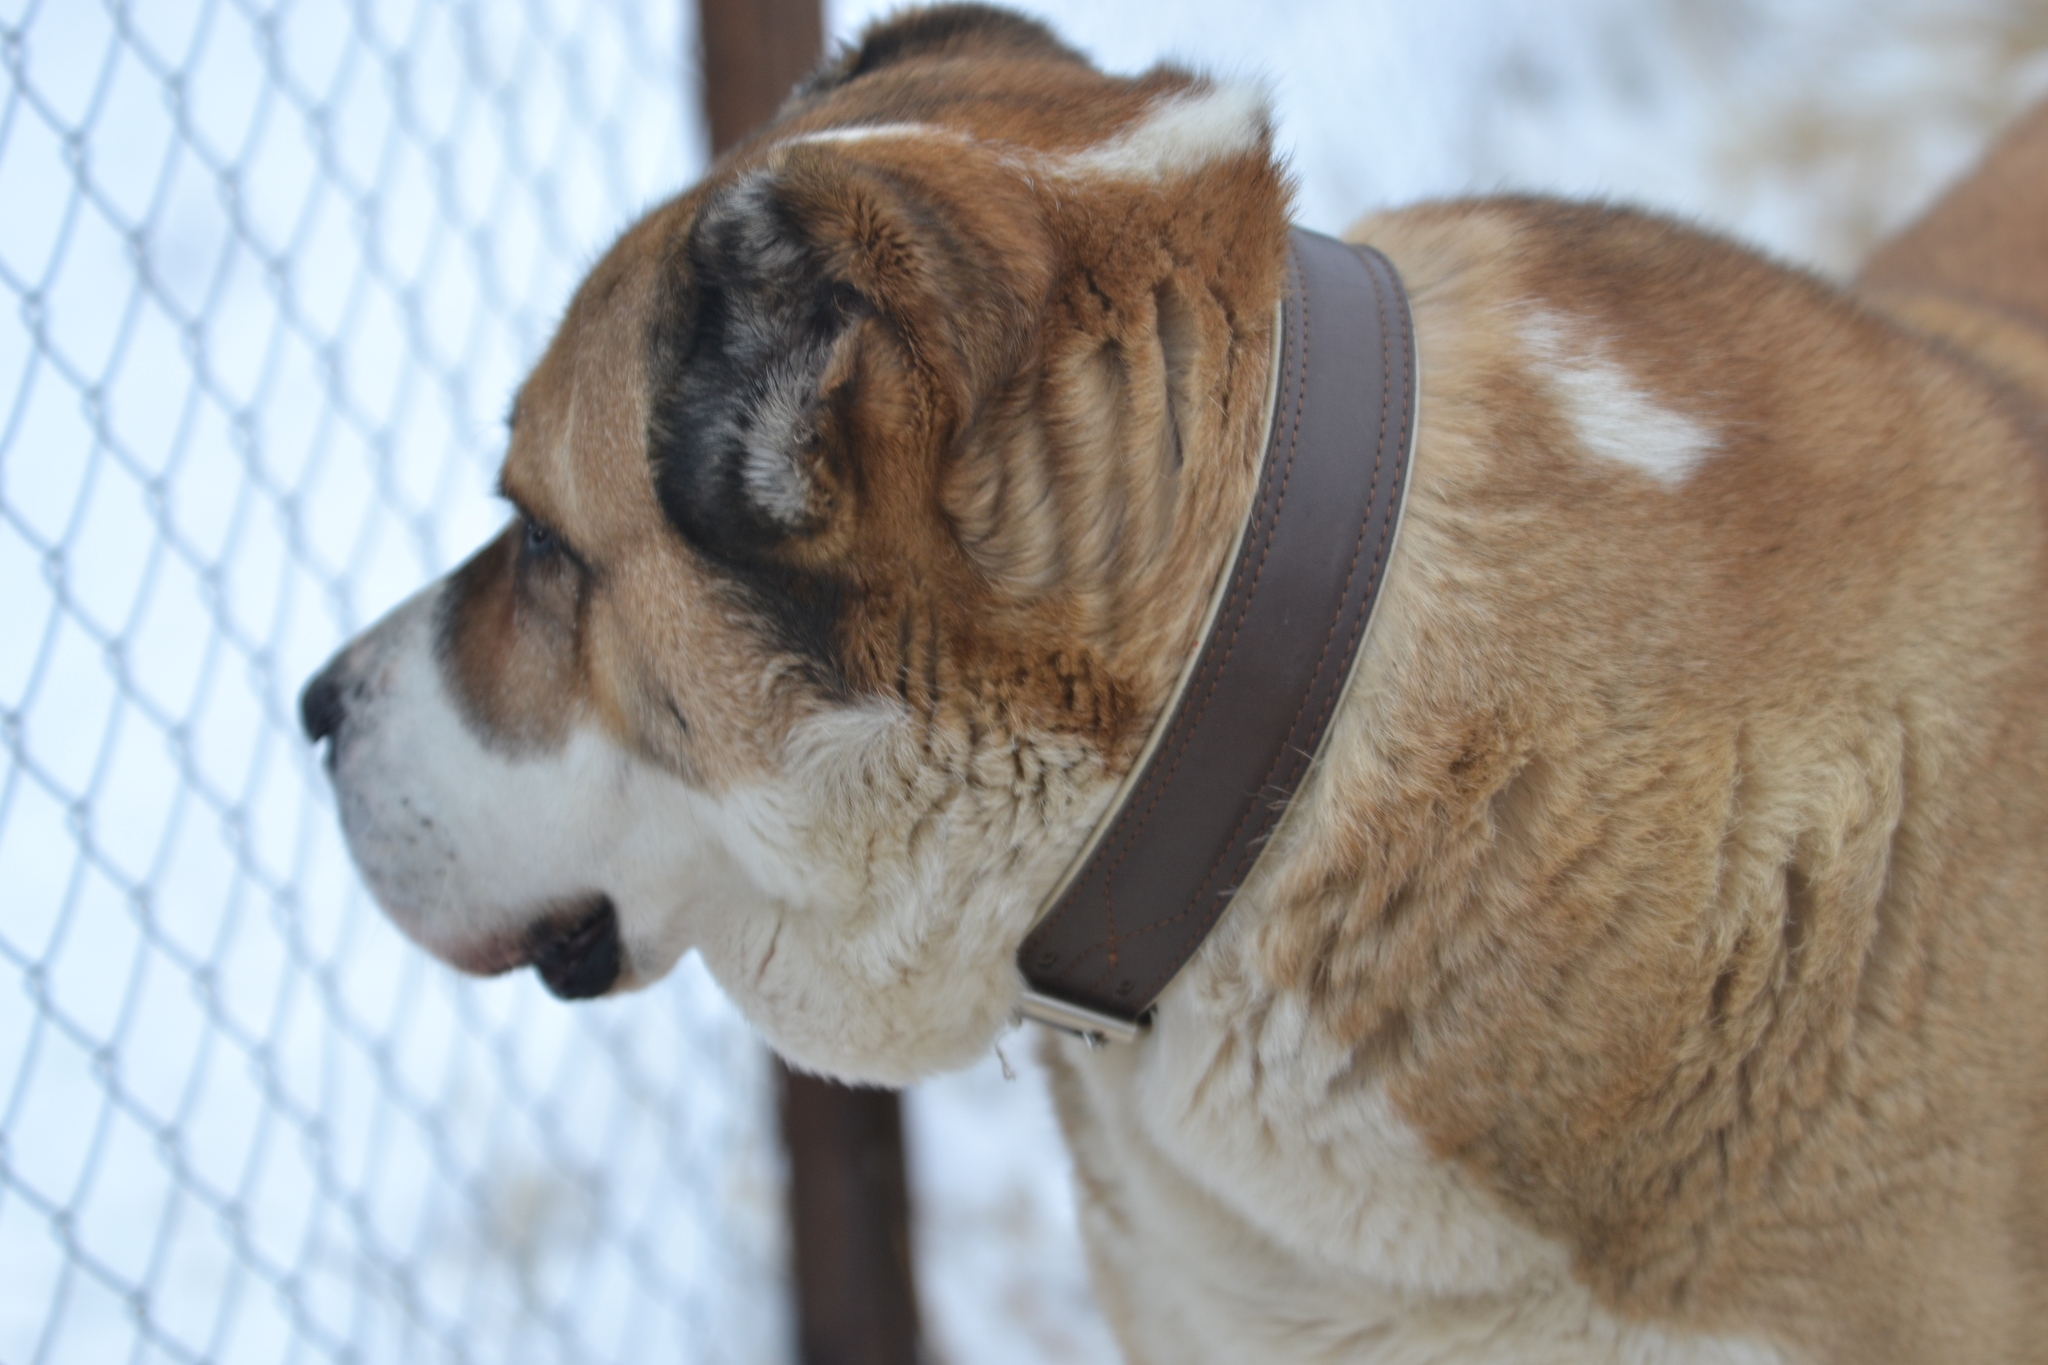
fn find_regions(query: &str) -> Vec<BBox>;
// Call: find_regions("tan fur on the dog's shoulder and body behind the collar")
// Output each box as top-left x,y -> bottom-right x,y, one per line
1294,205 -> 2048,1361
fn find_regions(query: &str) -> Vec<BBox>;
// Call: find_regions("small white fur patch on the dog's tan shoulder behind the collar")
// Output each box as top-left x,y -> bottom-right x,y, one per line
1522,311 -> 1720,487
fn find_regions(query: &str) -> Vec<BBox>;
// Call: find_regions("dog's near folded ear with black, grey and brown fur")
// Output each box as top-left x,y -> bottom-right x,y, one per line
649,147 -> 1049,569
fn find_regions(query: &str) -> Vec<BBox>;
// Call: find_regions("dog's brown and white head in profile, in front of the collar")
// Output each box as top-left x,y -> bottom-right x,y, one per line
303,6 -> 1286,1081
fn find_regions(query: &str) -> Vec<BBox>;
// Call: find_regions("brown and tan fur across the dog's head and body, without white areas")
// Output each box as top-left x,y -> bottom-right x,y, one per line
356,5 -> 2048,1361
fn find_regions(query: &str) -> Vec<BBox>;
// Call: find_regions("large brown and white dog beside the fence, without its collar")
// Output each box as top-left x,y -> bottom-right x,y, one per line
303,6 -> 2048,1365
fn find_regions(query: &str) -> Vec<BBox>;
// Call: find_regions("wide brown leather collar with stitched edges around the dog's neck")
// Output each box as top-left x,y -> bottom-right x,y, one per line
1018,229 -> 1417,1042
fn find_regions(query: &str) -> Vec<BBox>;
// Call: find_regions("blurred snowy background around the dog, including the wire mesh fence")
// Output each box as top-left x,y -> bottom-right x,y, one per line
0,0 -> 2048,1365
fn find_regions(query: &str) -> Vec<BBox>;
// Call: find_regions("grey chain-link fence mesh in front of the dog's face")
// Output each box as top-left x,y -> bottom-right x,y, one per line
0,0 -> 784,1365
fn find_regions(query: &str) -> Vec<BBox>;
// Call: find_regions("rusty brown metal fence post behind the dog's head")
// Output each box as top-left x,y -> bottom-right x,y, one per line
698,0 -> 920,1365
